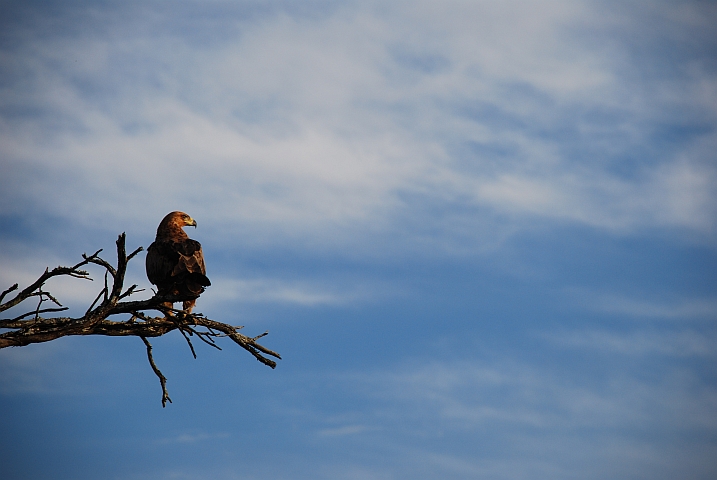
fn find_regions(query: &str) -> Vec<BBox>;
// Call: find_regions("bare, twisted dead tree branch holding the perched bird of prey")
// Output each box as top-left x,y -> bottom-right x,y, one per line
0,233 -> 281,407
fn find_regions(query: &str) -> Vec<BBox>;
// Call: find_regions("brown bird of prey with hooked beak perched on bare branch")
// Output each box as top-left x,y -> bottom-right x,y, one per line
145,212 -> 211,313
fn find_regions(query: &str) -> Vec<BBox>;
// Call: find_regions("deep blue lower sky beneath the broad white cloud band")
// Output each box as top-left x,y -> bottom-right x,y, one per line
2,229 -> 717,478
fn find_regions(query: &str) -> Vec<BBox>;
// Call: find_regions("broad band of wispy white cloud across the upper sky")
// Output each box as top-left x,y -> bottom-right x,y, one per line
0,1 -> 717,255
